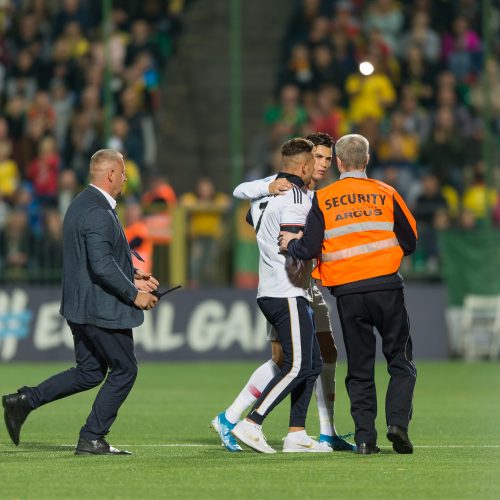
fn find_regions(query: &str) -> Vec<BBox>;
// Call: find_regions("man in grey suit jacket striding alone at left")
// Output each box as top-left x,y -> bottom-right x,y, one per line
2,149 -> 158,455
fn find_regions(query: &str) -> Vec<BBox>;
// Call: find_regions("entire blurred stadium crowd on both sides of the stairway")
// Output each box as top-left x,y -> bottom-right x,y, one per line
0,0 -> 500,283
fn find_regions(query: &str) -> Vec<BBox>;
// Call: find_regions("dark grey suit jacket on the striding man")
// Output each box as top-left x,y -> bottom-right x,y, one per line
60,186 -> 144,328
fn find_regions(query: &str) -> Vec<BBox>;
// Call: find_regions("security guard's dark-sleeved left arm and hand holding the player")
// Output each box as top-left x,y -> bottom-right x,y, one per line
280,195 -> 325,260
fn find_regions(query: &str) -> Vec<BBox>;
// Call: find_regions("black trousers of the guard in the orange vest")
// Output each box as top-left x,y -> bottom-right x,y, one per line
337,290 -> 417,444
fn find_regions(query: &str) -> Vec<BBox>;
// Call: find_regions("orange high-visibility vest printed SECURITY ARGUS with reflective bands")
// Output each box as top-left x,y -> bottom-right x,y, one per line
313,177 -> 417,286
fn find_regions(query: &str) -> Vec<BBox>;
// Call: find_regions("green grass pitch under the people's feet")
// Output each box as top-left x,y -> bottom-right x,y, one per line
0,362 -> 500,500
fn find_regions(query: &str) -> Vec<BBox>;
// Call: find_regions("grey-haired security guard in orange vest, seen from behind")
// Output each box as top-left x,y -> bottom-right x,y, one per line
279,134 -> 417,455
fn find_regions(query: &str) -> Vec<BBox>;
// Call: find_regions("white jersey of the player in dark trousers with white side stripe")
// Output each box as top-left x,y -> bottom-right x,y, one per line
250,186 -> 311,300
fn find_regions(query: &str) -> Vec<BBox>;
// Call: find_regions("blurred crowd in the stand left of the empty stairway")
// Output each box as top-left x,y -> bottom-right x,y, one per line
0,0 -> 185,281
